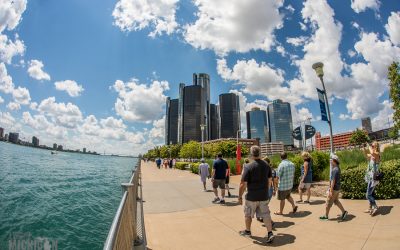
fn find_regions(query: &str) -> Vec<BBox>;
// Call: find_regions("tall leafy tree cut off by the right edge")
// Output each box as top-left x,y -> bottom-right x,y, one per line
388,62 -> 400,130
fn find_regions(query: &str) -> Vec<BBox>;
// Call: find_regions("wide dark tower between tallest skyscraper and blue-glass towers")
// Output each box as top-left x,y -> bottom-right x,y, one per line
219,93 -> 240,138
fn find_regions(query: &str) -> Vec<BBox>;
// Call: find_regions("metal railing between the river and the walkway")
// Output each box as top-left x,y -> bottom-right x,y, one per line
103,159 -> 147,250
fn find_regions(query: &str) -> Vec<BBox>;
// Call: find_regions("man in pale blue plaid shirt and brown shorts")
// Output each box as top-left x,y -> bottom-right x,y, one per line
275,152 -> 298,215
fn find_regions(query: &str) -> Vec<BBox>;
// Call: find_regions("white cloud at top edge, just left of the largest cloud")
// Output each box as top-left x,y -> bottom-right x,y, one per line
112,0 -> 178,37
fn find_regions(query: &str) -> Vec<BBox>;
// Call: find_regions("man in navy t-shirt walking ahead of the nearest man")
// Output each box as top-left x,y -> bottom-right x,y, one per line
211,154 -> 228,204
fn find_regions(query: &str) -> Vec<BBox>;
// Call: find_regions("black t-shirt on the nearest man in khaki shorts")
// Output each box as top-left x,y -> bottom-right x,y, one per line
242,160 -> 272,201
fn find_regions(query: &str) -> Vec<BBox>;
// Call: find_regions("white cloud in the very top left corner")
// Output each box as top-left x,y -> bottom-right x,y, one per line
0,0 -> 26,33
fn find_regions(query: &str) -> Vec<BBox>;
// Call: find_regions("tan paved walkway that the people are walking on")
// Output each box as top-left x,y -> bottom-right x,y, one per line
142,163 -> 400,250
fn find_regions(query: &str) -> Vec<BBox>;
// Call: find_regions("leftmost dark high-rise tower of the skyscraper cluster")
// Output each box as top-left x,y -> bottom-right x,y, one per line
165,97 -> 179,145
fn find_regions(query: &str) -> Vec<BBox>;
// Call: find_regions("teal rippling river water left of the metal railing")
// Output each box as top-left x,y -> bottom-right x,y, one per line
0,142 -> 137,249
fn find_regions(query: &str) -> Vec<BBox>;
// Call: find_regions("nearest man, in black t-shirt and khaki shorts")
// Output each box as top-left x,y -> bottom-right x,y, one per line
238,146 -> 274,243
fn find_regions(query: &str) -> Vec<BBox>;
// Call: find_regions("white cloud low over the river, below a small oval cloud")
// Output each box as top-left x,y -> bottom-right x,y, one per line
37,97 -> 82,128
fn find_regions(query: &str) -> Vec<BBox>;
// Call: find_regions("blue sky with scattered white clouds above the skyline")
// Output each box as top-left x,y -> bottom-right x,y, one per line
0,0 -> 400,155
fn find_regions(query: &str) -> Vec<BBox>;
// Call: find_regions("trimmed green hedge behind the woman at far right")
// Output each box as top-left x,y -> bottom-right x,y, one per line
341,159 -> 400,199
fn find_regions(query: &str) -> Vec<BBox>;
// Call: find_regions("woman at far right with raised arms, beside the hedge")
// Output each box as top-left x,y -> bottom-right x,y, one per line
365,141 -> 381,216
